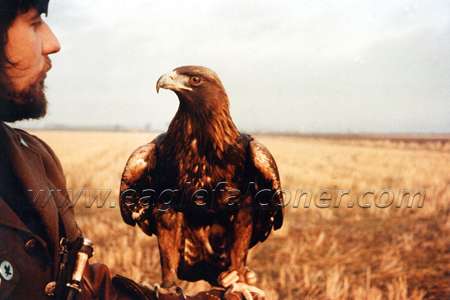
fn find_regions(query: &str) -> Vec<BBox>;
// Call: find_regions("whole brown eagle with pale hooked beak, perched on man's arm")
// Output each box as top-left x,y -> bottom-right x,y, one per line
120,66 -> 283,298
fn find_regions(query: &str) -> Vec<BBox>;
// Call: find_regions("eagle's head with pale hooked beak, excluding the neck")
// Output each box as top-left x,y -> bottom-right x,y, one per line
156,66 -> 229,110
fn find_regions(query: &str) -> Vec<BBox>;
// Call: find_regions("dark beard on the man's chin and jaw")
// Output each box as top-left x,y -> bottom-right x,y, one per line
0,72 -> 47,122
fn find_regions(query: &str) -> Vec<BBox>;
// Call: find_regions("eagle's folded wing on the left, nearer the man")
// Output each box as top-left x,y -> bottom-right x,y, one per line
119,135 -> 163,235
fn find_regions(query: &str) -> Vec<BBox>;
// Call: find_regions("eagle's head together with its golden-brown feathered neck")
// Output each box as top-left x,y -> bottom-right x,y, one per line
156,66 -> 239,152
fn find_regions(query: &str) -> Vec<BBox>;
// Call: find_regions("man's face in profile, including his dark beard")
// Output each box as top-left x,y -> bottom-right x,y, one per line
0,9 -> 60,122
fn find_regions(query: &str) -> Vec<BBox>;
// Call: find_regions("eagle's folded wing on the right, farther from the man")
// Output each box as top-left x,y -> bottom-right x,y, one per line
249,139 -> 284,247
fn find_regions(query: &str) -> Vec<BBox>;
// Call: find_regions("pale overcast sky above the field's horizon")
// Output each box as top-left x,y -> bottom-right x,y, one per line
19,0 -> 450,132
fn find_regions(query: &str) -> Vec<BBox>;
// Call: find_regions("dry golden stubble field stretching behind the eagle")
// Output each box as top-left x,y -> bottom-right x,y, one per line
36,132 -> 450,299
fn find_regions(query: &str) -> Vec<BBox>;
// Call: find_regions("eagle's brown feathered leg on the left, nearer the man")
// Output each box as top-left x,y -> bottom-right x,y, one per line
157,211 -> 183,288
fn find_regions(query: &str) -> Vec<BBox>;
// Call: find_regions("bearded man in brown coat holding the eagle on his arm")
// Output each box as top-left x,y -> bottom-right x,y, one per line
0,0 -> 246,300
